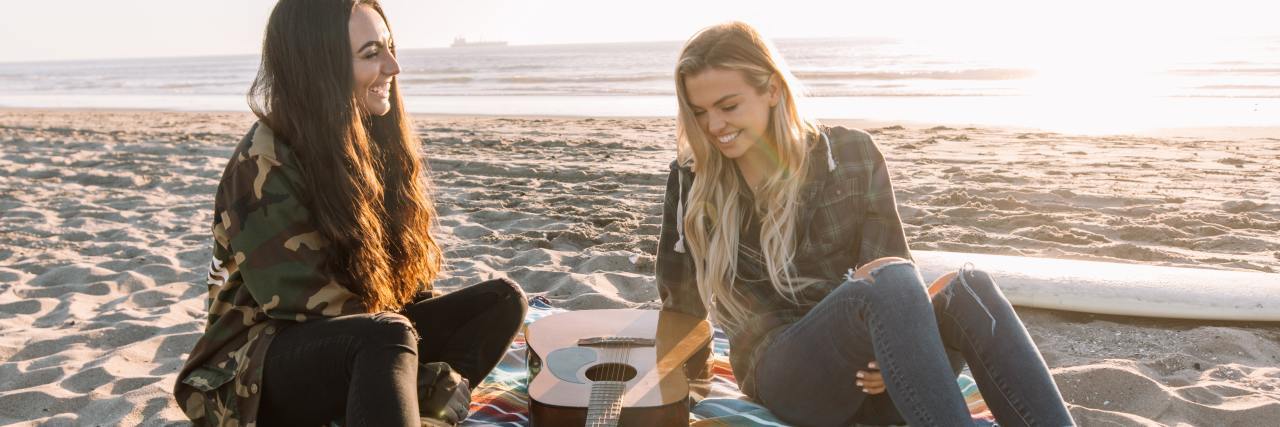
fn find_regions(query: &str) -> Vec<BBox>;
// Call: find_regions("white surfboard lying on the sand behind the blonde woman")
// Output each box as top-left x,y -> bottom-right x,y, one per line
911,251 -> 1280,321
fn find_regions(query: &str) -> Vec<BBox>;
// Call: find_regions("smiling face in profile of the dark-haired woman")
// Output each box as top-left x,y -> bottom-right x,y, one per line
348,5 -> 399,115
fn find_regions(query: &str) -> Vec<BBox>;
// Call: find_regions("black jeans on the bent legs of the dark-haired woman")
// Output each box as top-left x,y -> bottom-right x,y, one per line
259,279 -> 527,426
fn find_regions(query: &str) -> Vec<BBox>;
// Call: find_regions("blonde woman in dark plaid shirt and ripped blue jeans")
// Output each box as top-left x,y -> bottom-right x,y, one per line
658,23 -> 1073,426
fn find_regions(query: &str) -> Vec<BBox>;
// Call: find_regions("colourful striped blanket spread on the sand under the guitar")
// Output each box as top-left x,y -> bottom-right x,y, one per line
462,297 -> 995,427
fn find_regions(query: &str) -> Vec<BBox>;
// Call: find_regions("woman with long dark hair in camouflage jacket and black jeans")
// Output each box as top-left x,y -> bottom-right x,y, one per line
174,0 -> 526,426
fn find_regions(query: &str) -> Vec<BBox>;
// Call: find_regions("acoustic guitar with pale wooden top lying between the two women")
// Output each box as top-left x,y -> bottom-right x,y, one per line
525,309 -> 712,426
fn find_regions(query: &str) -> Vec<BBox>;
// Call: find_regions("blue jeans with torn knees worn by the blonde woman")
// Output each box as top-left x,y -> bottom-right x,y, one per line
755,261 -> 1074,426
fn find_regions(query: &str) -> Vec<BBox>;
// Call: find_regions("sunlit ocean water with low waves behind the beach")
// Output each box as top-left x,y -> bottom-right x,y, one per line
0,38 -> 1280,132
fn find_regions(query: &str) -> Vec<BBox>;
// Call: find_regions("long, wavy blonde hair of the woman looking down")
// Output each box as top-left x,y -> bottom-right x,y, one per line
676,22 -> 819,330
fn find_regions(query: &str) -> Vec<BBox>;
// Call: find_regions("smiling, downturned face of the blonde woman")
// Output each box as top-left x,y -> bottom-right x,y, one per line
685,68 -> 780,159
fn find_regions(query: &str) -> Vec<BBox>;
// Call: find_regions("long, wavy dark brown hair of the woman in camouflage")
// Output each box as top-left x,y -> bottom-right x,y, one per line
250,0 -> 443,312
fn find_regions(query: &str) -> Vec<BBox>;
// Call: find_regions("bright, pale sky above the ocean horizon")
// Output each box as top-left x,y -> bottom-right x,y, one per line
0,0 -> 1280,63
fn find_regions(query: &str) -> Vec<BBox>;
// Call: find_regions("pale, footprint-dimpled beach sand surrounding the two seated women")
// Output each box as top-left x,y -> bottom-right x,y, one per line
0,110 -> 1280,426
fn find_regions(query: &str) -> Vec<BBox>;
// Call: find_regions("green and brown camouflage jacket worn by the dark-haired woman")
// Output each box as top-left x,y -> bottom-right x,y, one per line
174,123 -> 365,426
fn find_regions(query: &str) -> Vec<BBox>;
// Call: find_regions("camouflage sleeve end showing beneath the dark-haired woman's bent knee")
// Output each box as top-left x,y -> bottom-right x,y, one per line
417,362 -> 471,424
